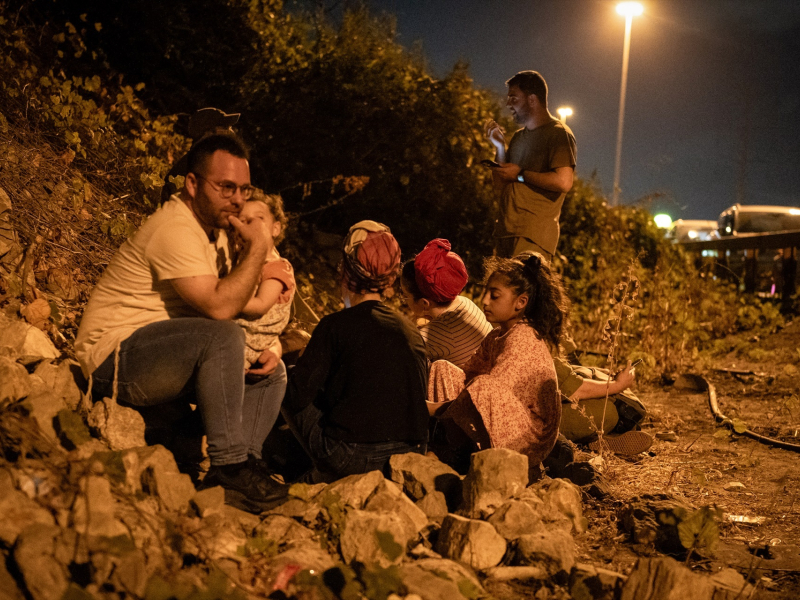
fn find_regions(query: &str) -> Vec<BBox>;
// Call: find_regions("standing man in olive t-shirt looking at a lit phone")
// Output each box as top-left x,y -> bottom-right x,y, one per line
486,71 -> 576,259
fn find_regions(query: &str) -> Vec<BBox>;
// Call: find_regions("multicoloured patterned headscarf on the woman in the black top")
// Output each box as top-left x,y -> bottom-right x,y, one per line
342,221 -> 400,293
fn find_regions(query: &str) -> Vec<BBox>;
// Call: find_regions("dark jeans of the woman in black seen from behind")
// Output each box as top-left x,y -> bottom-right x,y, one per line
283,404 -> 428,481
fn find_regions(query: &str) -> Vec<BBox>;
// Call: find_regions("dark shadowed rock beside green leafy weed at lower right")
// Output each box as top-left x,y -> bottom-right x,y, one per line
620,494 -> 693,554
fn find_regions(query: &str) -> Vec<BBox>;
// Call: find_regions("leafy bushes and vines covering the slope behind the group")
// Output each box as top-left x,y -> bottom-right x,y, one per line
0,0 -> 783,378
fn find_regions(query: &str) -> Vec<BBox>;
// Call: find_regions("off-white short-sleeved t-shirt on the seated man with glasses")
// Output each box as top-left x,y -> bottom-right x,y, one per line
75,196 -> 230,377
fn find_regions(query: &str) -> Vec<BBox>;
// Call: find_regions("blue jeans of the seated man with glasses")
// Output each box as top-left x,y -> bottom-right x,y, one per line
92,318 -> 286,465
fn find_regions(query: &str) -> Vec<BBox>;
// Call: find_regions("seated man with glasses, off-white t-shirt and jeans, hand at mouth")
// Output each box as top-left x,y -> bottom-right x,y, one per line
75,134 -> 286,512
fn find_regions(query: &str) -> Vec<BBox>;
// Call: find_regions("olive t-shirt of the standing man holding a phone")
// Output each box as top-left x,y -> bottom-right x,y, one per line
494,120 -> 577,256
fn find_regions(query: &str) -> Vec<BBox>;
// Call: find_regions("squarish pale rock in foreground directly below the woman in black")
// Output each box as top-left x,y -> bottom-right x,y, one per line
339,510 -> 409,567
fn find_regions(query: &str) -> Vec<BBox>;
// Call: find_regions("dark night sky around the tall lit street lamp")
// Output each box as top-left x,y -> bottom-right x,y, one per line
370,0 -> 800,219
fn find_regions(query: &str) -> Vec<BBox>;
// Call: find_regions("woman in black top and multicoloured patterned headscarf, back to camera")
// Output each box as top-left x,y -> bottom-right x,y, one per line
283,221 -> 428,482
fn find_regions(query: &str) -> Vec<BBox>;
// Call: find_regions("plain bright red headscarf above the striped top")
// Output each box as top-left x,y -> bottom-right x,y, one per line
414,238 -> 469,303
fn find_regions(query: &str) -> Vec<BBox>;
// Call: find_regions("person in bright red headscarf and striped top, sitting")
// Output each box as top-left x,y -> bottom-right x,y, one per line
400,239 -> 492,367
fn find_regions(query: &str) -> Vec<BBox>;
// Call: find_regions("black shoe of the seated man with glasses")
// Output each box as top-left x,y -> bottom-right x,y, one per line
199,461 -> 289,514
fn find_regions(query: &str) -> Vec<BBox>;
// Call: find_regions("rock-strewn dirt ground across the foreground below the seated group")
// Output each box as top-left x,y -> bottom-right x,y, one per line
0,308 -> 800,600
